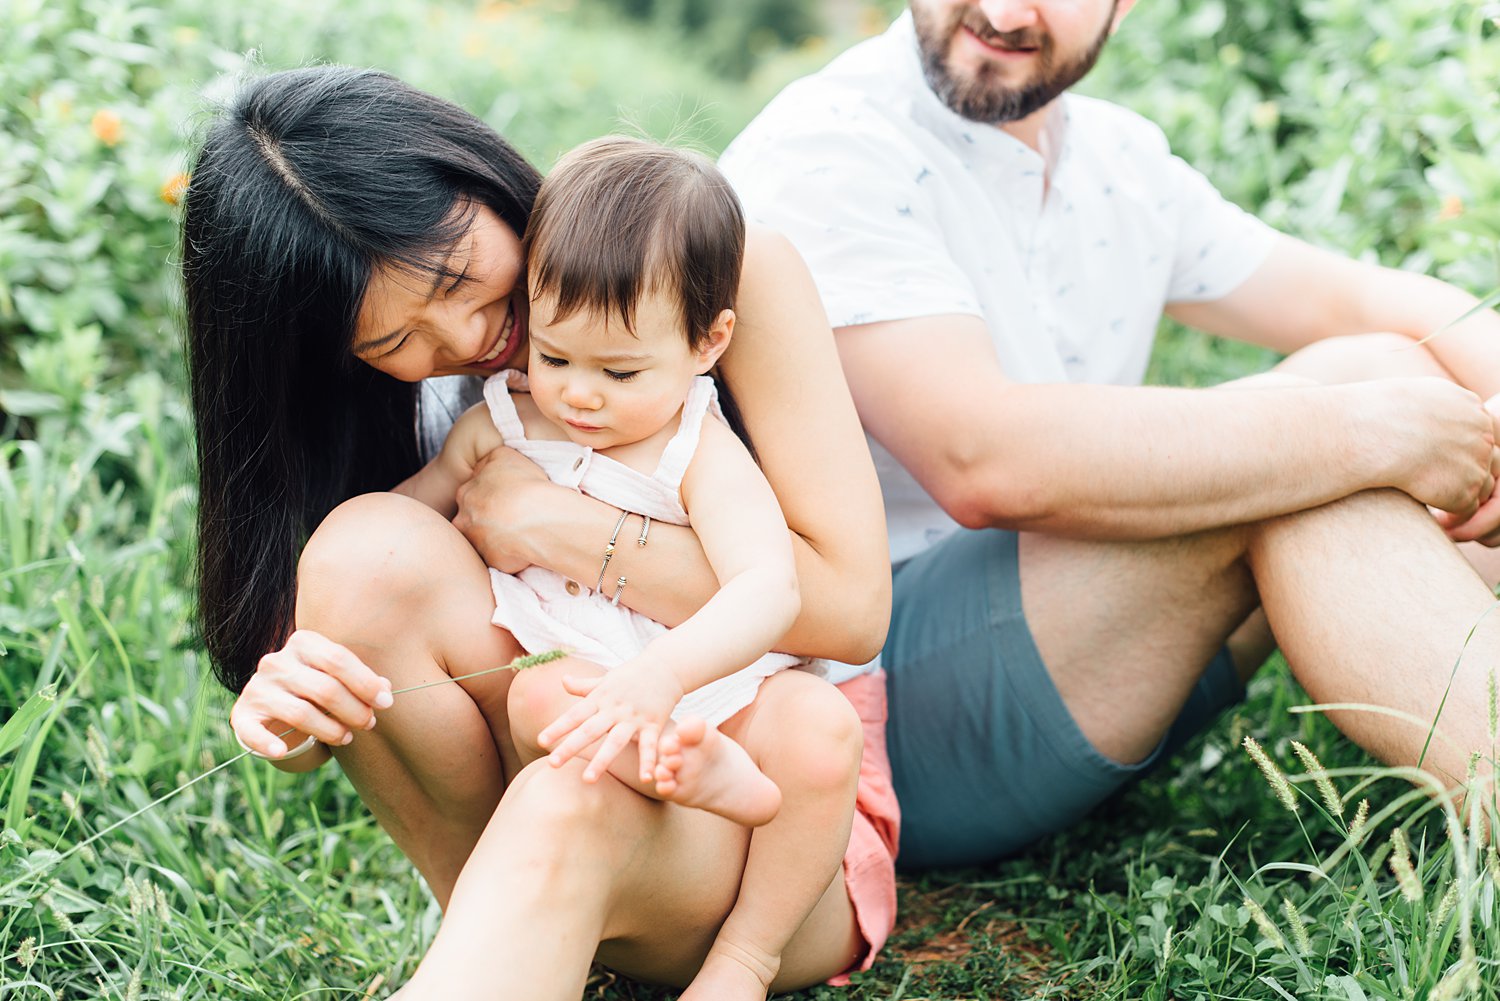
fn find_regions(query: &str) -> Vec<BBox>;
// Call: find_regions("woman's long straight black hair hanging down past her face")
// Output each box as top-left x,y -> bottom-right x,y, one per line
183,66 -> 540,690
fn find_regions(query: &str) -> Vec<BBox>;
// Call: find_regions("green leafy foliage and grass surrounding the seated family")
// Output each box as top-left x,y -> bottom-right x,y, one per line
0,0 -> 1500,1001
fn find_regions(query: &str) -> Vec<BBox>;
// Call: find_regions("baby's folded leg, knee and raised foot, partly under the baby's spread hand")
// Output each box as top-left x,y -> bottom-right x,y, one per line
507,657 -> 782,827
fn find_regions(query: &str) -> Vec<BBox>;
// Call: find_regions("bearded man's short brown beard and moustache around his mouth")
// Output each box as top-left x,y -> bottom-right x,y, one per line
912,0 -> 1118,125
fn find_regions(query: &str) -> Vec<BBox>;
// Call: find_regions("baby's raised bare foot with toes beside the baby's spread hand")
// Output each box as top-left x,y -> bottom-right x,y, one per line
656,716 -> 782,827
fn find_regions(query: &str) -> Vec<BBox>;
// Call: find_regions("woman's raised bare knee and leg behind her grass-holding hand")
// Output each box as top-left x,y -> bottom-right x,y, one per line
297,494 -> 519,905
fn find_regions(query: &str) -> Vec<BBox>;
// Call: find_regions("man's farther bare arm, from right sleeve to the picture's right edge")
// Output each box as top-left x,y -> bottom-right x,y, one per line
1167,236 -> 1500,399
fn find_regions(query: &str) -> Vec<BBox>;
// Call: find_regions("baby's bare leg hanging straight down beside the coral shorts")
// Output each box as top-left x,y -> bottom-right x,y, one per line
659,671 -> 864,1001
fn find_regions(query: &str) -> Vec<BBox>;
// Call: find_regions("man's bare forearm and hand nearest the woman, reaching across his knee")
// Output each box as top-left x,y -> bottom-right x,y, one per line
837,315 -> 1493,539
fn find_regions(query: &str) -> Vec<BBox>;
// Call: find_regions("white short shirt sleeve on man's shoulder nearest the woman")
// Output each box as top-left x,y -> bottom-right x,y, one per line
720,120 -> 983,327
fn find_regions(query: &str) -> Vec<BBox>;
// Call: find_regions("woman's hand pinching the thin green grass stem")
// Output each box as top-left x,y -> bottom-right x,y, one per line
230,629 -> 395,759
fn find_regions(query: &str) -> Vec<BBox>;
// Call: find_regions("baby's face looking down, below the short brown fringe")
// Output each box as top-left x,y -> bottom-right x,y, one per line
527,285 -> 719,449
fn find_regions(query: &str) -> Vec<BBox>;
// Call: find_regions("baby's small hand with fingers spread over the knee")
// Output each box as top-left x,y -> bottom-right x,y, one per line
537,663 -> 683,782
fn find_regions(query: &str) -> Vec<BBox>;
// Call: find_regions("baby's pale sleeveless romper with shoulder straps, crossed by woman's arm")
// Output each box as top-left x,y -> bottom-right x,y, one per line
485,372 -> 806,726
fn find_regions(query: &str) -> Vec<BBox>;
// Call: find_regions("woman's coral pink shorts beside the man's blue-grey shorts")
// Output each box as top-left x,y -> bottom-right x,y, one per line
828,671 -> 902,987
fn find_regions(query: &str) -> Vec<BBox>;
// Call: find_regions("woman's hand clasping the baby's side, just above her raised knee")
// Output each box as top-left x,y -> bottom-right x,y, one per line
453,446 -> 567,573
